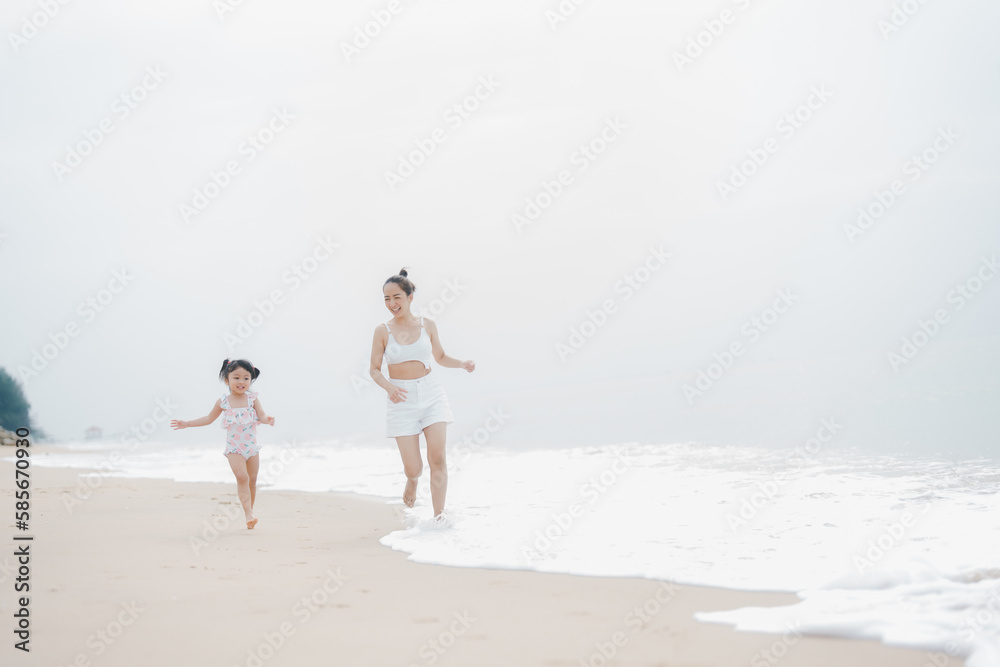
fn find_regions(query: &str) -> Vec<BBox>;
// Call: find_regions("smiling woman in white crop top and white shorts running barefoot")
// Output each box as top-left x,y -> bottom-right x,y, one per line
371,269 -> 476,519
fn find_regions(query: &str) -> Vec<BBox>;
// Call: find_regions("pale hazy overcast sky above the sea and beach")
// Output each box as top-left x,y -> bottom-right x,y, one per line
0,0 -> 1000,451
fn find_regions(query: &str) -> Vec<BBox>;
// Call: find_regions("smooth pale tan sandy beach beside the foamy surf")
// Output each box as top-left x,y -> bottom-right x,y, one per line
0,448 -> 963,667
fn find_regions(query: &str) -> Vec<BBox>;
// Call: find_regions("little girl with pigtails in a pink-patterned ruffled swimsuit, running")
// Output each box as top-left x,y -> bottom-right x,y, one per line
170,359 -> 274,530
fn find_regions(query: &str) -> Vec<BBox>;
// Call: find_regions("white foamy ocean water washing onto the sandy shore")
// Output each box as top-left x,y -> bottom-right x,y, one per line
15,438 -> 1000,667
